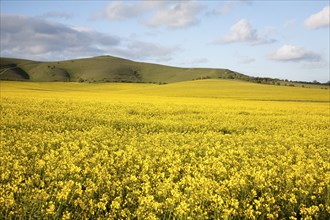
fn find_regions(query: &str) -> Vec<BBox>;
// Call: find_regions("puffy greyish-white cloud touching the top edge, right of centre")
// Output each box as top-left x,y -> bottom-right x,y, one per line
146,1 -> 205,29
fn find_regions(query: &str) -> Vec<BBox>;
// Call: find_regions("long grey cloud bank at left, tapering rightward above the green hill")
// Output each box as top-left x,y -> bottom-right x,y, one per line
0,14 -> 178,61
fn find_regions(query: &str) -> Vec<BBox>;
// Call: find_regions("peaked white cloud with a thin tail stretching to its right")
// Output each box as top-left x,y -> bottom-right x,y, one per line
218,19 -> 275,45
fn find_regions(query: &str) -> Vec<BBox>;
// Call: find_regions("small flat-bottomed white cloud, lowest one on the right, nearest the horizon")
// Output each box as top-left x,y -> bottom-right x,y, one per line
269,45 -> 322,62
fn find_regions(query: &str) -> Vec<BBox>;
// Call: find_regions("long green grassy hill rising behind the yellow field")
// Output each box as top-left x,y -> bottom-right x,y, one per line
0,56 -> 248,84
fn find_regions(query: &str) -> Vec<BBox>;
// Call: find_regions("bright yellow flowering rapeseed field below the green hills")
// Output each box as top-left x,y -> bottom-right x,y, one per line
0,80 -> 330,219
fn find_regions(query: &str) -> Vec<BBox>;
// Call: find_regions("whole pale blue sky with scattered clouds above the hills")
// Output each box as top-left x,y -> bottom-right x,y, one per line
0,0 -> 330,82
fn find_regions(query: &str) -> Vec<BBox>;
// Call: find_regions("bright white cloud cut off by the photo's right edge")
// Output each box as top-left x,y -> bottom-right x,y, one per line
304,6 -> 330,29
